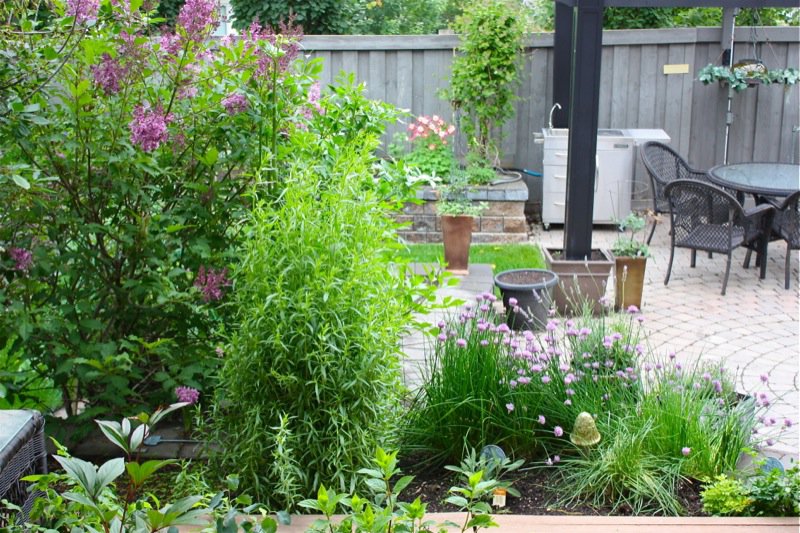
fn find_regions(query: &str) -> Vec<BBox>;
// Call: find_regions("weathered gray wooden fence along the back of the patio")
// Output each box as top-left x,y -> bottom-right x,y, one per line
303,28 -> 800,171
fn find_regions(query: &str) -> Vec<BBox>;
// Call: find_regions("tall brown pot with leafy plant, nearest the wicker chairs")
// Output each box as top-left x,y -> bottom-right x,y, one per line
611,213 -> 650,309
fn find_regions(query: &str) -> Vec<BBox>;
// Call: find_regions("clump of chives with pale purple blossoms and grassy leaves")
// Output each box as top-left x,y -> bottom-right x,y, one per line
405,294 -> 792,514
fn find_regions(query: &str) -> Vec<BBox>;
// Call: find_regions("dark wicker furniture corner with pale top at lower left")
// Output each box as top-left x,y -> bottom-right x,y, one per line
0,411 -> 47,527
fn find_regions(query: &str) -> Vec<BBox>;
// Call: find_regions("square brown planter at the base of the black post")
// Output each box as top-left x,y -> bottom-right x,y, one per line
543,248 -> 614,316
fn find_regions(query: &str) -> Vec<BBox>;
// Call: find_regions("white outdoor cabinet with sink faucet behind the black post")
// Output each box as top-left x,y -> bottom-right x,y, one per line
542,128 -> 634,229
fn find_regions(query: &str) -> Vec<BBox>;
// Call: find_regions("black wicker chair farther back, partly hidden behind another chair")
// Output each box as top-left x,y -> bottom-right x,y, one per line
641,141 -> 711,244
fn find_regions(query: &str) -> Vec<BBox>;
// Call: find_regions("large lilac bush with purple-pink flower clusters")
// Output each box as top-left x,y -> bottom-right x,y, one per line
0,0 -> 340,426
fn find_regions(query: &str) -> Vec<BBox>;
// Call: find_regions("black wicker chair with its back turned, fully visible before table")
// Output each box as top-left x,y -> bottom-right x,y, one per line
664,179 -> 775,295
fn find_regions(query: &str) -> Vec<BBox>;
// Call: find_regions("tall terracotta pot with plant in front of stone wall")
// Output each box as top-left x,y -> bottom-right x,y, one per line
436,171 -> 487,275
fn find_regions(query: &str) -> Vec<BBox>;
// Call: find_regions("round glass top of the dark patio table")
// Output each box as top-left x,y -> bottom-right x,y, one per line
708,163 -> 800,196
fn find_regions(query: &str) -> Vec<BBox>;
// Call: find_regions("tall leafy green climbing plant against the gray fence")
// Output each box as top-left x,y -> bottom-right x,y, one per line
446,0 -> 525,163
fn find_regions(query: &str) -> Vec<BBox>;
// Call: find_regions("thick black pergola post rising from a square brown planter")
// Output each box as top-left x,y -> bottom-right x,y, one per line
564,0 -> 603,259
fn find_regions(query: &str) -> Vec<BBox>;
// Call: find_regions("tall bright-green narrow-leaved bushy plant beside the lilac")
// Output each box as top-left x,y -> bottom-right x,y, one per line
212,118 -> 428,508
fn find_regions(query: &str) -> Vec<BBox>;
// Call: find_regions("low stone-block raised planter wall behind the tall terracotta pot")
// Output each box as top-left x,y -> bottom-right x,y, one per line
396,181 -> 528,243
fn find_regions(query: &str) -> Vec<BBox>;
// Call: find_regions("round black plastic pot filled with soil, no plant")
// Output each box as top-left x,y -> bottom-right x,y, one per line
494,268 -> 558,330
